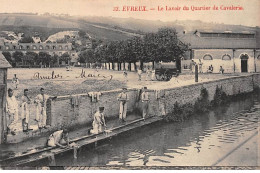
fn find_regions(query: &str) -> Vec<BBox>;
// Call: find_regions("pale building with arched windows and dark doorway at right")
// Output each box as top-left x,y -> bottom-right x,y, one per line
180,31 -> 260,73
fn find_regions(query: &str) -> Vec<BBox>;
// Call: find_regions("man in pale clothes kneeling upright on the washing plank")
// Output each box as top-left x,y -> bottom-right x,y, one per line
90,107 -> 106,134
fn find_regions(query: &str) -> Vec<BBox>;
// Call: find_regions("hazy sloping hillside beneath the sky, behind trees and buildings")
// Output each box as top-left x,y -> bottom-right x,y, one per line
0,13 -> 259,41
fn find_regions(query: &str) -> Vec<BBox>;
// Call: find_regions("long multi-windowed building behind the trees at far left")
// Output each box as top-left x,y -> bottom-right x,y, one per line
0,40 -> 78,65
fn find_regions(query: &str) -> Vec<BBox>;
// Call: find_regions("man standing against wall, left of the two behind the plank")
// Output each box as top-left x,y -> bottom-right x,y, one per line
117,88 -> 128,122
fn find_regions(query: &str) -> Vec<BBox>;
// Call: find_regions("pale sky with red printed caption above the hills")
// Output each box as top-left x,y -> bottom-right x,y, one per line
0,0 -> 260,26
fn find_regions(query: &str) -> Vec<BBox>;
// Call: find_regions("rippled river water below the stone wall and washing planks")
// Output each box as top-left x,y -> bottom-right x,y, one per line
56,95 -> 260,166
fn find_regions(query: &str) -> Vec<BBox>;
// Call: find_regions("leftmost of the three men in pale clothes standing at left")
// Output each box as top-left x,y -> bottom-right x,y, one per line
6,88 -> 18,135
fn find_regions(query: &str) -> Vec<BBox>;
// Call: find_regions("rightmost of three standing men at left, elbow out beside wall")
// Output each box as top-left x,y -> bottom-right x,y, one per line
35,88 -> 50,129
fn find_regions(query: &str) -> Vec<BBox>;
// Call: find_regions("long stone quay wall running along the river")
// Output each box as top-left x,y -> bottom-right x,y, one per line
47,74 -> 260,130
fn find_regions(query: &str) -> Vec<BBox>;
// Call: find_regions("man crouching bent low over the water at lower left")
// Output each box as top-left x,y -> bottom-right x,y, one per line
47,129 -> 69,148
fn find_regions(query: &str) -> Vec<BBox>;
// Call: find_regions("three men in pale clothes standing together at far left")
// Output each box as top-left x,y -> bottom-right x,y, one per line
6,88 -> 50,135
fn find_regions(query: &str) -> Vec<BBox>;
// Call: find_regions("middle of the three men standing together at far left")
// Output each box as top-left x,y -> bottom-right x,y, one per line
20,89 -> 31,132
